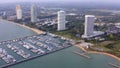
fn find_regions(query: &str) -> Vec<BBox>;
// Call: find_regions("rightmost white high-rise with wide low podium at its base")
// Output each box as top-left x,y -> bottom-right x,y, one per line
82,15 -> 104,38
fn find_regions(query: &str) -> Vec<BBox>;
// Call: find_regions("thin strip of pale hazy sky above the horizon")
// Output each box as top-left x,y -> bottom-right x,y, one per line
0,0 -> 120,3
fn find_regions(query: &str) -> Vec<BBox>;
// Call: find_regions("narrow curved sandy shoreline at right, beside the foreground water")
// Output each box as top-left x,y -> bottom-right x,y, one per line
75,45 -> 120,61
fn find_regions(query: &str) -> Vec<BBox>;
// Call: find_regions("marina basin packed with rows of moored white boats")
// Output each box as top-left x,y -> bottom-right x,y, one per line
0,33 -> 72,68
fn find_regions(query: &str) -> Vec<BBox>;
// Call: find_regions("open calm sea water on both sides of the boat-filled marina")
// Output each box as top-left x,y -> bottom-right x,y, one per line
0,21 -> 120,68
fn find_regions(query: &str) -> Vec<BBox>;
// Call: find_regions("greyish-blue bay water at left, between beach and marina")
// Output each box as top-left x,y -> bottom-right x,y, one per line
0,20 -> 36,41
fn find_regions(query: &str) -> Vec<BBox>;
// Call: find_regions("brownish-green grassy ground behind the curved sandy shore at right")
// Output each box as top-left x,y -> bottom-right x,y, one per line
90,39 -> 120,57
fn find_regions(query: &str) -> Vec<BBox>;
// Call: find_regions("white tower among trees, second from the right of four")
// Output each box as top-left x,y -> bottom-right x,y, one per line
57,10 -> 66,31
